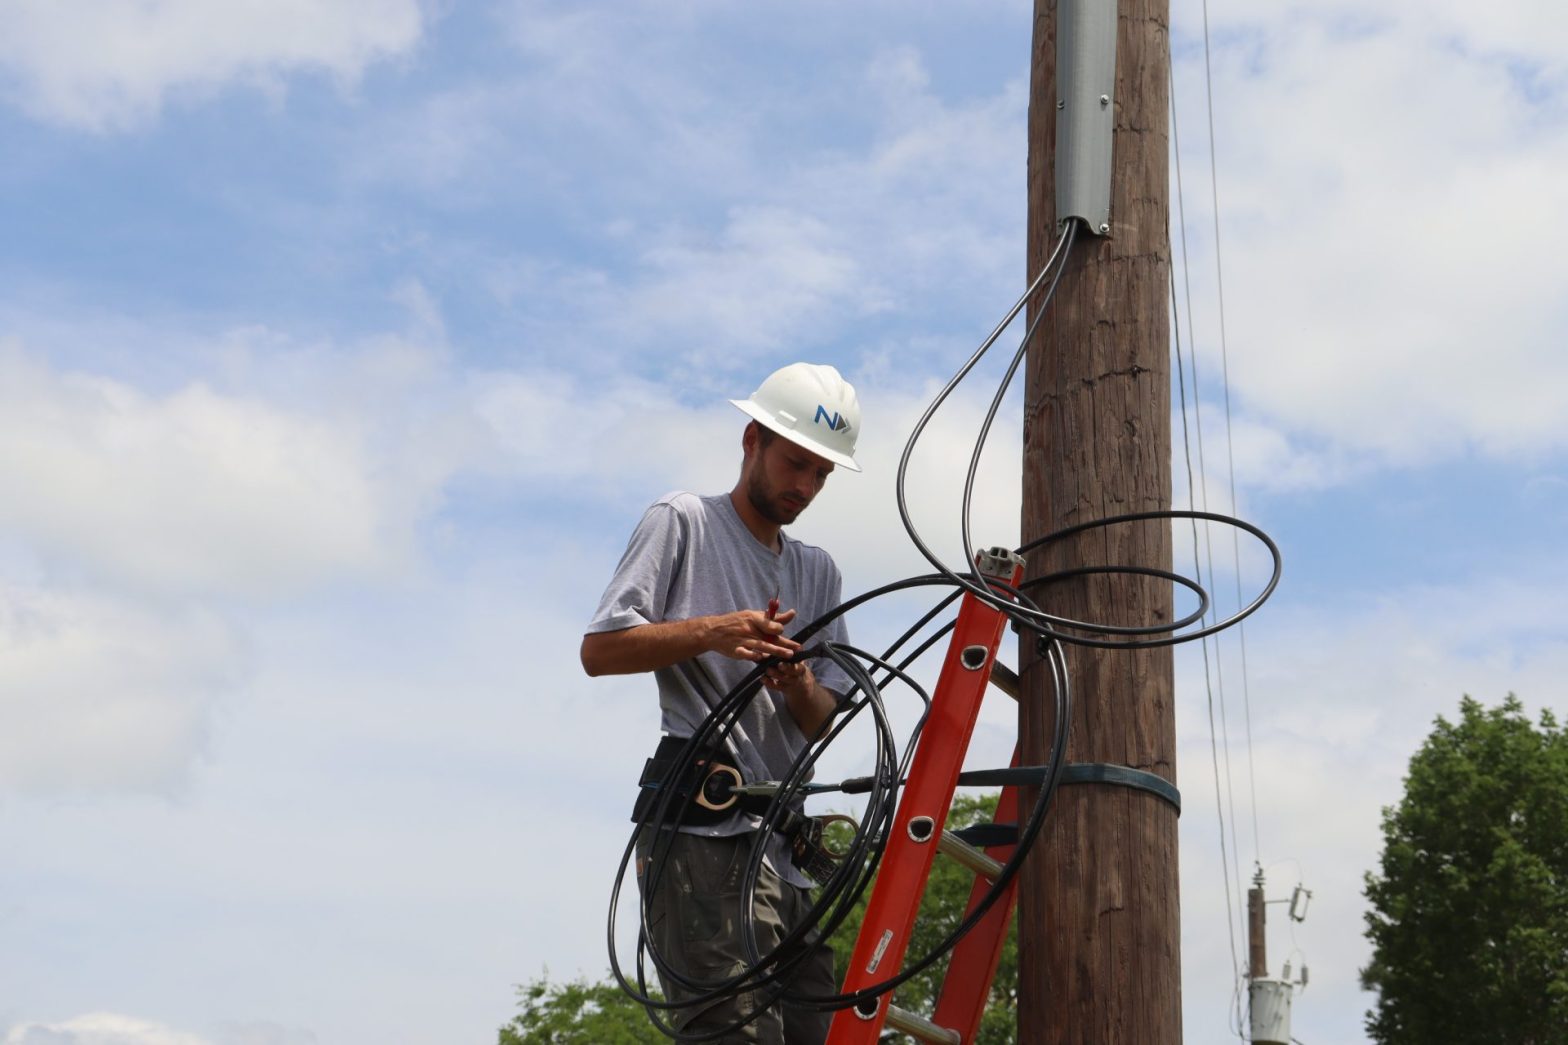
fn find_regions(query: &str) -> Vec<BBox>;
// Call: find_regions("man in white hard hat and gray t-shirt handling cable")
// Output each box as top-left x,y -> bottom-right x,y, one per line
582,362 -> 861,1045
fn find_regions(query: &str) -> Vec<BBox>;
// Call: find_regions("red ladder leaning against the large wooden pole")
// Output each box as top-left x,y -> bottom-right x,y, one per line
828,548 -> 1024,1045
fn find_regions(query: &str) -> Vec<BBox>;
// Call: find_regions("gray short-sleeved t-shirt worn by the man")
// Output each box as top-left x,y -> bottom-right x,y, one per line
586,493 -> 851,885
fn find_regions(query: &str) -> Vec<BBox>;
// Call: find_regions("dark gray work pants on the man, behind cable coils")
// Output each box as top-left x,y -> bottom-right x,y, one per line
637,828 -> 837,1045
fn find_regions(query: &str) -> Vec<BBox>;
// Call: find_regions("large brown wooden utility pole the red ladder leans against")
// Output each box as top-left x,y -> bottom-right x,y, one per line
1018,0 -> 1181,1045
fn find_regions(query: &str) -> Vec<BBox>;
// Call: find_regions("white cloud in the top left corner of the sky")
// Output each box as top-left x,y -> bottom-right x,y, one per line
0,0 -> 423,130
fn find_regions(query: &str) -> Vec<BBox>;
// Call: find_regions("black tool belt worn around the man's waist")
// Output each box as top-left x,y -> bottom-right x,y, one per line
632,736 -> 839,882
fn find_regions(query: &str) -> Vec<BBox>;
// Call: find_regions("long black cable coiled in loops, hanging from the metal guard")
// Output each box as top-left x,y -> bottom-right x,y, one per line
608,214 -> 1281,1042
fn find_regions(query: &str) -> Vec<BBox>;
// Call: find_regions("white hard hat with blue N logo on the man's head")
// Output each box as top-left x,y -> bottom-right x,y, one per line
729,362 -> 861,472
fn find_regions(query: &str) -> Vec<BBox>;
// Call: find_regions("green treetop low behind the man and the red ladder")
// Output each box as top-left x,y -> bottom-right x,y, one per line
499,794 -> 1018,1045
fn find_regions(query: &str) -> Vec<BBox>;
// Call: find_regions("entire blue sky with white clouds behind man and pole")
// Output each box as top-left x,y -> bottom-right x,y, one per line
0,0 -> 1568,1045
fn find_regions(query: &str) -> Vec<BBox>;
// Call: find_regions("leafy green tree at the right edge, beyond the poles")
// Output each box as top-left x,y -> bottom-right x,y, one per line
1361,694 -> 1568,1045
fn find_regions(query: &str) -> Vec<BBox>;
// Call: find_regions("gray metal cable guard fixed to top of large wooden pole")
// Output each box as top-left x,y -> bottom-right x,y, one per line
1057,0 -> 1116,235
